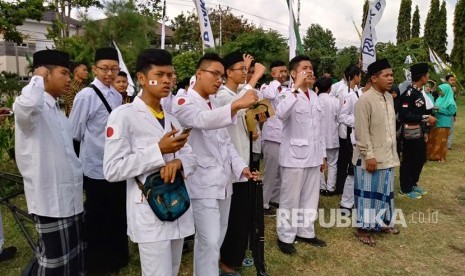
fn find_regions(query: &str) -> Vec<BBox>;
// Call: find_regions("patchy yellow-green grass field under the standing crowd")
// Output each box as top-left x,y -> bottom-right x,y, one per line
0,99 -> 465,276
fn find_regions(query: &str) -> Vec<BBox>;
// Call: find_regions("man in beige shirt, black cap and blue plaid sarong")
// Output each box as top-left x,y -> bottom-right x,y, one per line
354,59 -> 399,246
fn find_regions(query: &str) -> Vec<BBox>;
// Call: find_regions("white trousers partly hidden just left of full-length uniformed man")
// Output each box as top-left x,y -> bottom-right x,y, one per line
263,141 -> 282,209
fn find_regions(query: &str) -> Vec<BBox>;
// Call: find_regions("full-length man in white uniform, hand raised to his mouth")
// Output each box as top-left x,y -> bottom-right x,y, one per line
276,56 -> 326,254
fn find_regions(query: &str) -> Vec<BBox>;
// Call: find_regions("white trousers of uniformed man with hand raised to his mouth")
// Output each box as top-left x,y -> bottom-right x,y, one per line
276,166 -> 321,243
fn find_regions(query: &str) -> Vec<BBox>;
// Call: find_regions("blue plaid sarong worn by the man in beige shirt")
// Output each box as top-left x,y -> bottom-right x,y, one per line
354,166 -> 394,231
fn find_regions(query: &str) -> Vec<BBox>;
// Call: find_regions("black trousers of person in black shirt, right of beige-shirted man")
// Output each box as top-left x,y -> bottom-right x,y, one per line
400,139 -> 426,193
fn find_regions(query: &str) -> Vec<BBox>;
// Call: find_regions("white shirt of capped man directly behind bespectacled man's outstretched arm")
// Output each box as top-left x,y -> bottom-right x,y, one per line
212,85 -> 252,166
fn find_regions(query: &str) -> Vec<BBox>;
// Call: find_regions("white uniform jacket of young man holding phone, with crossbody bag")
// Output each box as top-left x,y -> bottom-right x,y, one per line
103,97 -> 197,243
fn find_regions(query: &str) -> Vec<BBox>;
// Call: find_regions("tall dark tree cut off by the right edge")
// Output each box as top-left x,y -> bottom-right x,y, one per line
450,0 -> 465,78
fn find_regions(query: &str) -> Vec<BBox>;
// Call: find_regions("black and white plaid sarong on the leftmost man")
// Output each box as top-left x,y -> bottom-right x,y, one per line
33,214 -> 84,276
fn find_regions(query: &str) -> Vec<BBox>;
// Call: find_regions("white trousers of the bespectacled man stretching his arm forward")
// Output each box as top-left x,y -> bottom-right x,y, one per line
191,197 -> 231,276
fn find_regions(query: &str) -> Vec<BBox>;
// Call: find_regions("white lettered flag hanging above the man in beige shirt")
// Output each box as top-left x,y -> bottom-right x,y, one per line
362,0 -> 386,72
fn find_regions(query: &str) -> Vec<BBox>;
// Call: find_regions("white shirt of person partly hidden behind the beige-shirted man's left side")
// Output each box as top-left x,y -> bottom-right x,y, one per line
339,89 -> 363,144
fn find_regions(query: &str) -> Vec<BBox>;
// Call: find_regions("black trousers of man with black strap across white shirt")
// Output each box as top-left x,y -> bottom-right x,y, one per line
84,176 -> 129,273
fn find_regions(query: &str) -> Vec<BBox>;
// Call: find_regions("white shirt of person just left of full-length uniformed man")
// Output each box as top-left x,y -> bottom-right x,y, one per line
260,80 -> 288,143
